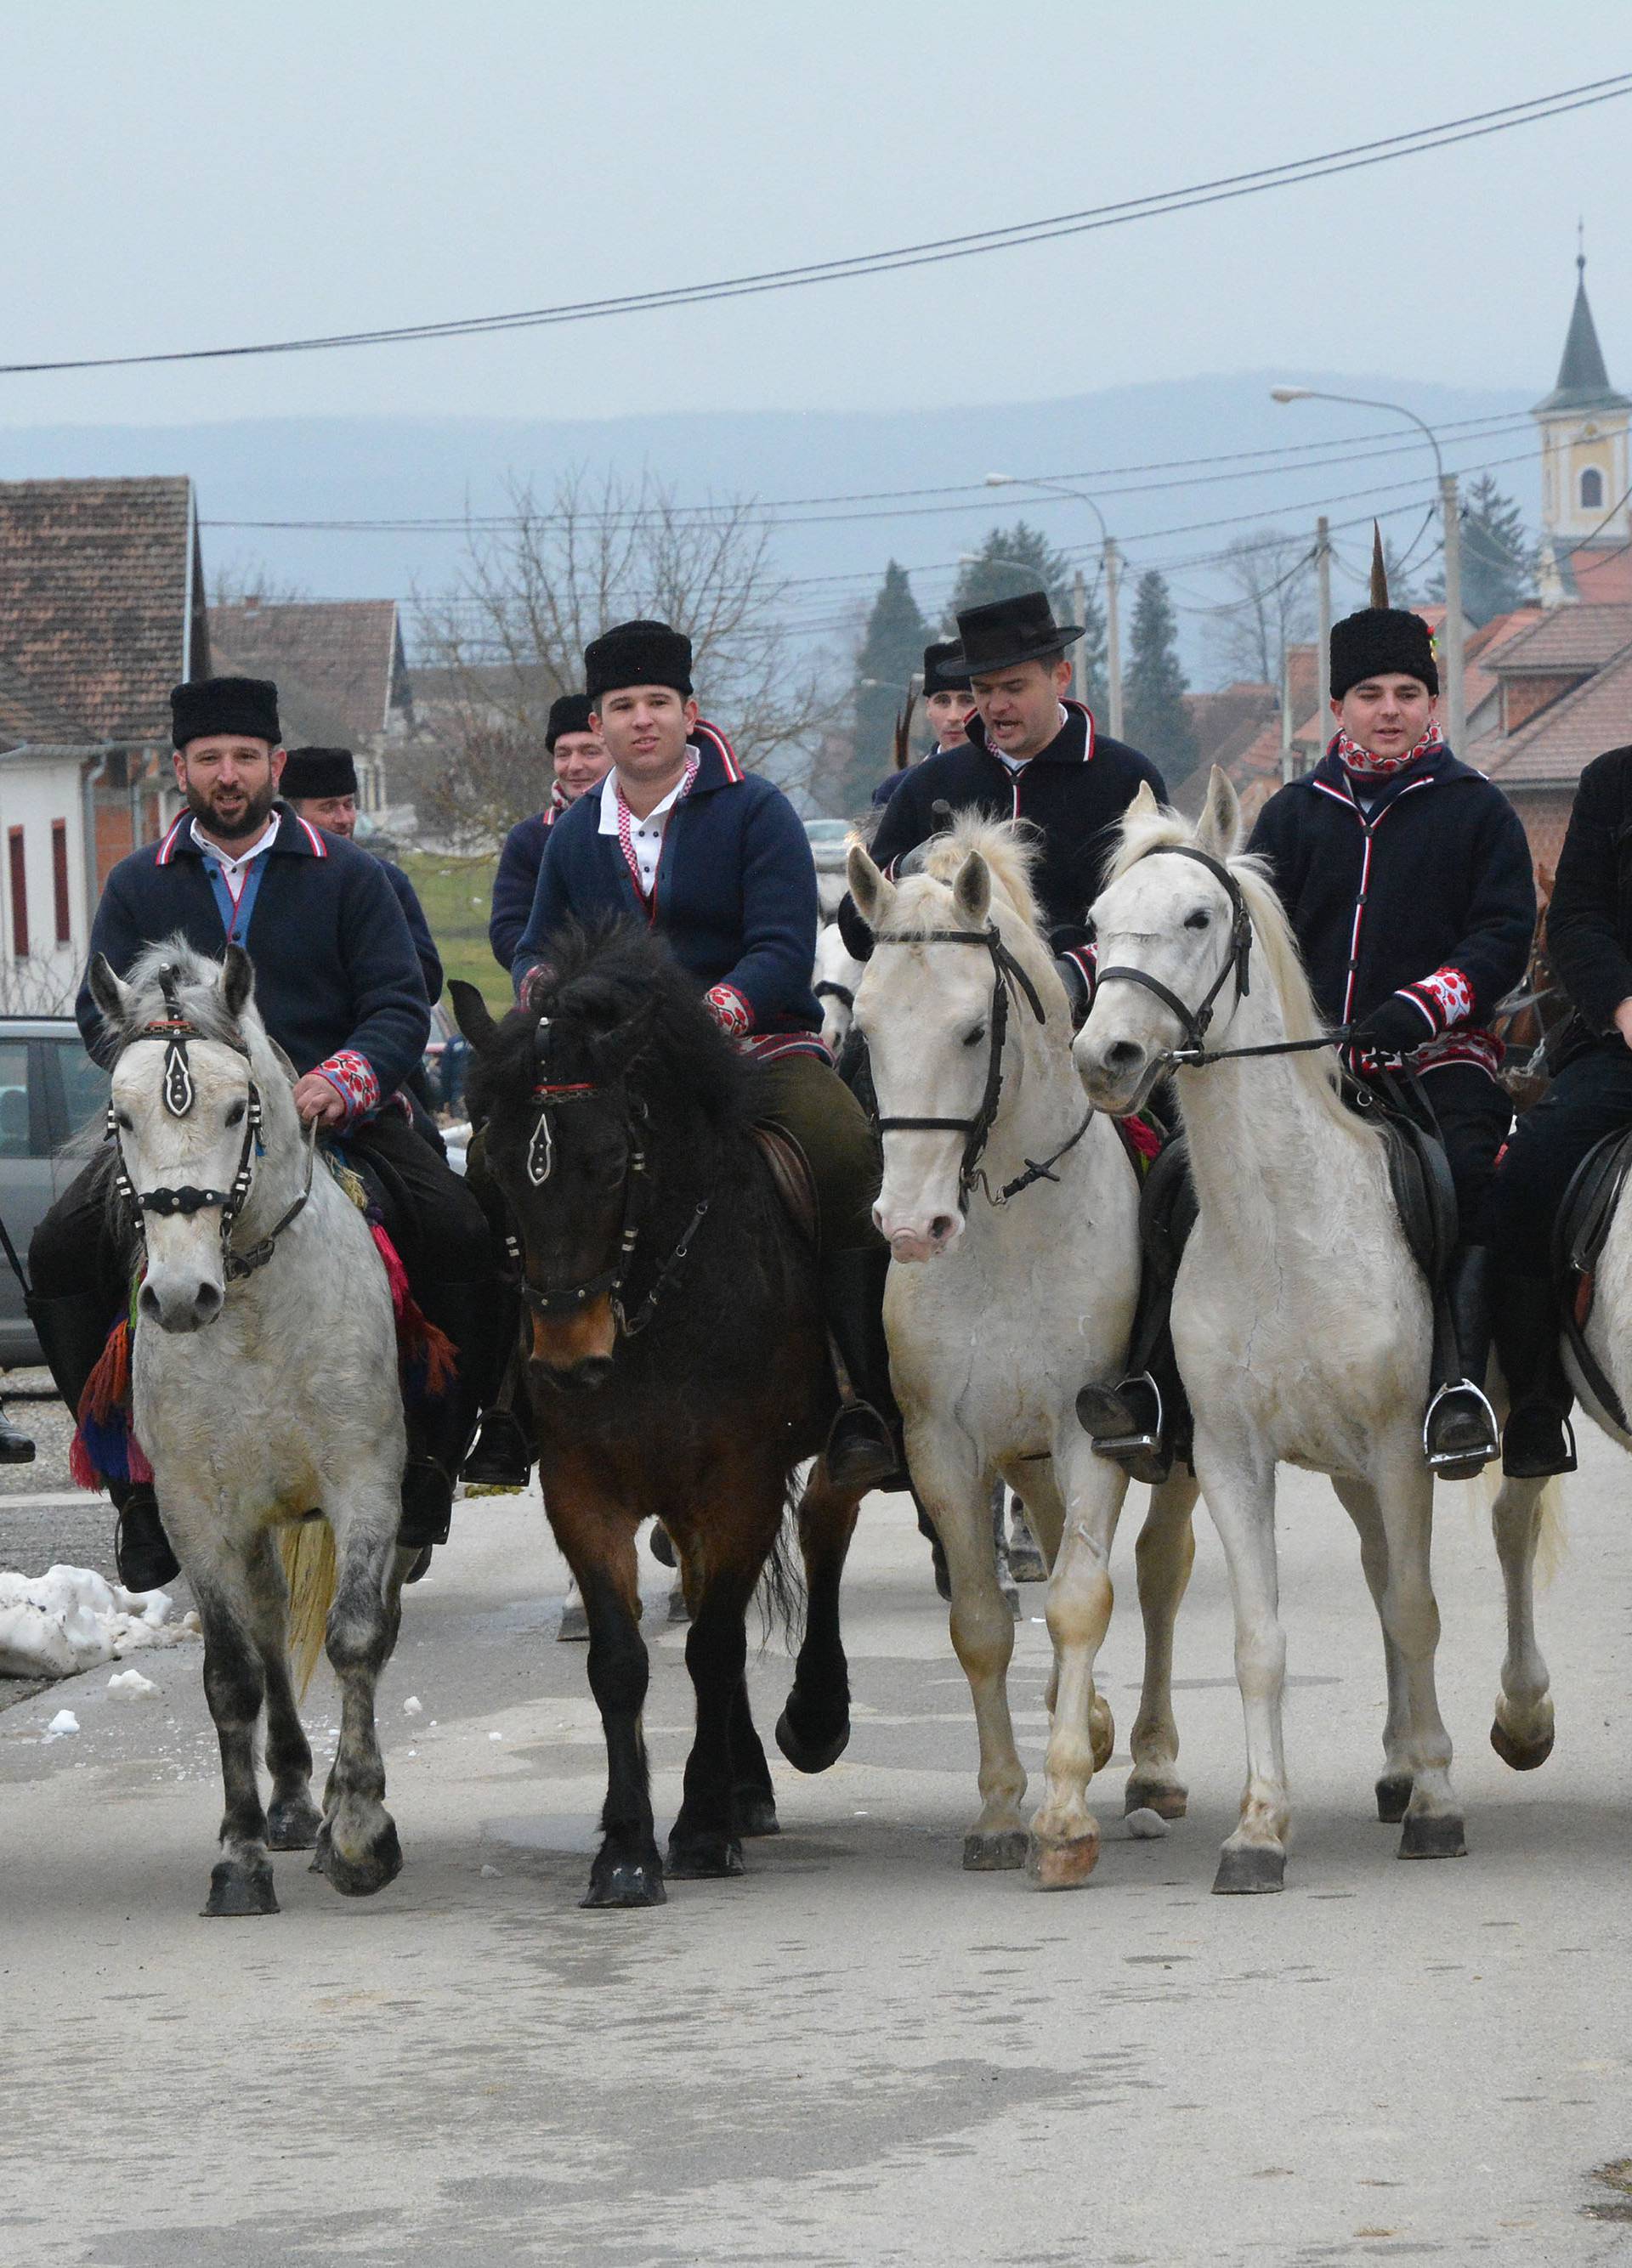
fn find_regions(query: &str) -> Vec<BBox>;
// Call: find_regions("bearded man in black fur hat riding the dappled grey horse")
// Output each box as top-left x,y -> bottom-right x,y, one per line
30,678 -> 508,1590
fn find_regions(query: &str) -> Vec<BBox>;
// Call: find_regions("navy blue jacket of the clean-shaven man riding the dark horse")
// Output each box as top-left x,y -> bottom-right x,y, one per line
513,723 -> 822,1037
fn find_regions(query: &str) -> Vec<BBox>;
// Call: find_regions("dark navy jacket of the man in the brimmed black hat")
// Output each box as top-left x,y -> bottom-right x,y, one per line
862,701 -> 1167,957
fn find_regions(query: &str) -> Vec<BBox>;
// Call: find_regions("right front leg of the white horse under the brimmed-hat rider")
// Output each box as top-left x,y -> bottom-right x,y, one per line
1026,1434 -> 1128,1889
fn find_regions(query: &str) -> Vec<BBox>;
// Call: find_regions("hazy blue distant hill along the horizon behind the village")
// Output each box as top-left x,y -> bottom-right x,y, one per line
0,370 -> 1546,685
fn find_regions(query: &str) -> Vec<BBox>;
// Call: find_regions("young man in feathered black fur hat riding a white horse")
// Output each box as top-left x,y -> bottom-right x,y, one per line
1080,565 -> 1537,1479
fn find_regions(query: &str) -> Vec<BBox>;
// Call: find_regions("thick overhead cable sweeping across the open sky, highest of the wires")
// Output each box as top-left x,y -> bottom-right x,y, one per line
0,71 -> 1632,376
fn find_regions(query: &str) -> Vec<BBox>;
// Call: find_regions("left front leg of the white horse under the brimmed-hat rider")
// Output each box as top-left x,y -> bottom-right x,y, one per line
905,1420 -> 1026,1874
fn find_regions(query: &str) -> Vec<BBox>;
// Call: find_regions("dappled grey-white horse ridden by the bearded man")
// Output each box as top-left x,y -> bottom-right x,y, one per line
91,936 -> 413,1915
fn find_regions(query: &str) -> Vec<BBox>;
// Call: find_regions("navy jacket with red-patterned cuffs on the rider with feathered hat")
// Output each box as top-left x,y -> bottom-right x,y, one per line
1249,749 -> 1537,1041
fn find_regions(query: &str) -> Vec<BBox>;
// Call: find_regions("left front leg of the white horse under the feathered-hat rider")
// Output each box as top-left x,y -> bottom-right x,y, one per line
1196,1420 -> 1291,1896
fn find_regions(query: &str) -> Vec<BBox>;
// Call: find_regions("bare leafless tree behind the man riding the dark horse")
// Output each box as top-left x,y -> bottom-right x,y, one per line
406,472 -> 842,846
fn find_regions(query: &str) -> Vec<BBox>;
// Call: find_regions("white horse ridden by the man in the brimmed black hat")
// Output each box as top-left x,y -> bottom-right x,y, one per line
849,819 -> 1196,1889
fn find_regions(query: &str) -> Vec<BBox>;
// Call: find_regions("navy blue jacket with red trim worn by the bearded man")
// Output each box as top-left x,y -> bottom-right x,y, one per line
75,803 -> 431,1118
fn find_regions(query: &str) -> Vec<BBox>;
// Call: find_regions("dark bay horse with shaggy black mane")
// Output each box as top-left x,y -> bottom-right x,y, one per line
451,923 -> 858,1905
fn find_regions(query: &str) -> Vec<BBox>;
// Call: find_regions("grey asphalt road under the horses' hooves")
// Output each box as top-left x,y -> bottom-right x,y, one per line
0,1435 -> 1632,2268
